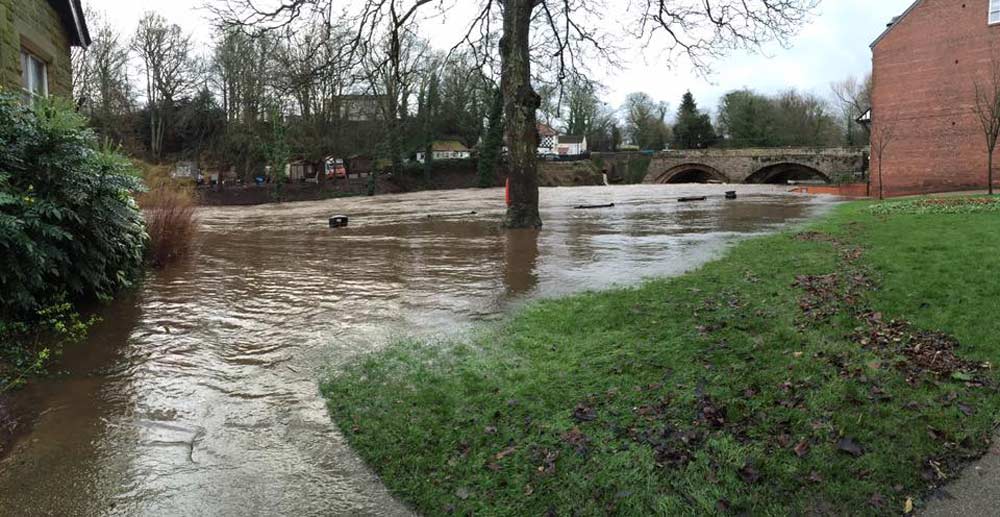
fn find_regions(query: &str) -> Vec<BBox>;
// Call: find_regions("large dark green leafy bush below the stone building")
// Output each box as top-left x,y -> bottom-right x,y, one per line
0,92 -> 147,322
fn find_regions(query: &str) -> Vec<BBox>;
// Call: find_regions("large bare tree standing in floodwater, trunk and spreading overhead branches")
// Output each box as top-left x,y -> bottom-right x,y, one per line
215,0 -> 818,228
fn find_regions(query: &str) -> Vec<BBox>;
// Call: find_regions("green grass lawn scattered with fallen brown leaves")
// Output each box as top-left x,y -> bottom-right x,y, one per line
323,197 -> 1000,515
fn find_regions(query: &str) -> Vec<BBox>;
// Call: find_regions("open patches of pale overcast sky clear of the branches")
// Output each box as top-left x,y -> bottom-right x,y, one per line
87,0 -> 912,116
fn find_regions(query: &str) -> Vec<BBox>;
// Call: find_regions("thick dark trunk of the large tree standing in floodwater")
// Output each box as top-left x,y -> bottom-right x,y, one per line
500,0 -> 542,228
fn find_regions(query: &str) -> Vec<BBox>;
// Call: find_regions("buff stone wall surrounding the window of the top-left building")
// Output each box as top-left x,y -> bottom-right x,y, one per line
0,0 -> 73,97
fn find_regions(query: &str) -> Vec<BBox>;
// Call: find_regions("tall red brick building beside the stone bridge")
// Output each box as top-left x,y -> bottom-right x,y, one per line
871,0 -> 1000,196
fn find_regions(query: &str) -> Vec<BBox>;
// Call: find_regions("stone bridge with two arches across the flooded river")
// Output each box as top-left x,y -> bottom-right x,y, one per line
592,148 -> 868,184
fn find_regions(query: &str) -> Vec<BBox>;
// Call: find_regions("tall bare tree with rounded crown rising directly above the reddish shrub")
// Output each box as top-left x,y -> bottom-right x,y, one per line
132,12 -> 194,159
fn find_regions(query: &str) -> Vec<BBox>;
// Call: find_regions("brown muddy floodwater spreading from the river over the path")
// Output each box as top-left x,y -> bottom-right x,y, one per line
0,185 -> 831,516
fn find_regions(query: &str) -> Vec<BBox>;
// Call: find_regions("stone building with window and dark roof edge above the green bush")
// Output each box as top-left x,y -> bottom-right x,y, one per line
0,0 -> 90,97
